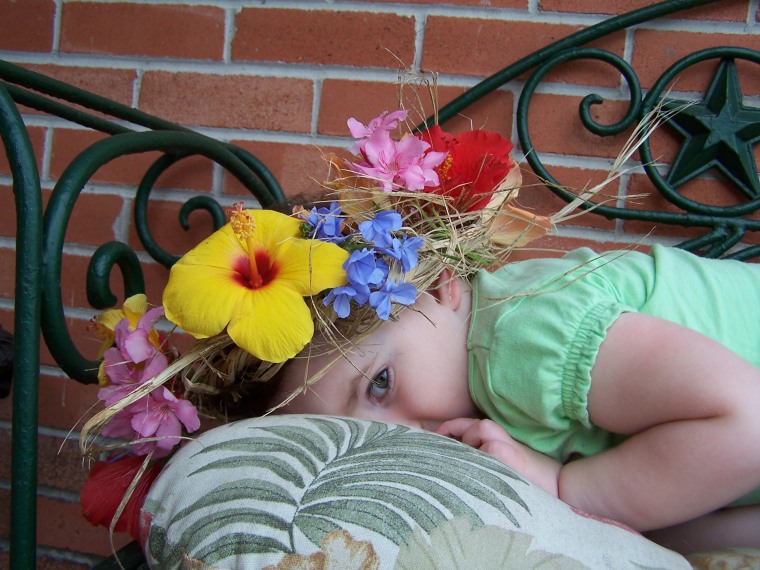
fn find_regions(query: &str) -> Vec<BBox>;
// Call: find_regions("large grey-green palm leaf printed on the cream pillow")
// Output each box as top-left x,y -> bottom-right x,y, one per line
145,417 -> 528,565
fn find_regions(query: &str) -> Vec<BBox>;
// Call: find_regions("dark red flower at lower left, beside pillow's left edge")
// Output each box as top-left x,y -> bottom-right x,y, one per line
80,456 -> 161,540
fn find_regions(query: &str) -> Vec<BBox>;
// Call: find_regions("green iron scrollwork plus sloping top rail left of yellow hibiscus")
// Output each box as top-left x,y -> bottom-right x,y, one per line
0,57 -> 283,383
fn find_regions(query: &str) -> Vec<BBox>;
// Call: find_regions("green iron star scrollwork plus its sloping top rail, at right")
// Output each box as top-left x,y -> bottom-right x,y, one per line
430,0 -> 760,259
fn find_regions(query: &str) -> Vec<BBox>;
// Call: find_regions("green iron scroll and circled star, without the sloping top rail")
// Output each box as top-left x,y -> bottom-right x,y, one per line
517,47 -> 760,259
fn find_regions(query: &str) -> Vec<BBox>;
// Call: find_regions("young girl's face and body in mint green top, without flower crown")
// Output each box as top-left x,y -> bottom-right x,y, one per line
275,246 -> 760,551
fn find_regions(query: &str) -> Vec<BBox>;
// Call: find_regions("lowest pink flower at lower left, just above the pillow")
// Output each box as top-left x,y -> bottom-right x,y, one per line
131,387 -> 201,452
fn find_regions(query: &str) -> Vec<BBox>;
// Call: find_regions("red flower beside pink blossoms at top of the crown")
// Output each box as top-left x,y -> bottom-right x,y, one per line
417,125 -> 515,212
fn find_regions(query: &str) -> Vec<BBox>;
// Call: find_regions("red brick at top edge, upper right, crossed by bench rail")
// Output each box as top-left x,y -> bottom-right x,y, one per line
539,0 -> 747,22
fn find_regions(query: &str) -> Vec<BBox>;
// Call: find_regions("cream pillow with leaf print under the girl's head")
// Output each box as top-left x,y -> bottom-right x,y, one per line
141,415 -> 690,570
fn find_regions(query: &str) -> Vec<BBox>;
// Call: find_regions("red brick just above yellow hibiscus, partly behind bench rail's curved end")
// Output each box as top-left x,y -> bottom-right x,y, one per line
224,141 -> 342,201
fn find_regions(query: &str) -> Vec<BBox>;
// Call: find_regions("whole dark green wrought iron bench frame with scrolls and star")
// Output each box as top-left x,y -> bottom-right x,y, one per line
0,0 -> 760,569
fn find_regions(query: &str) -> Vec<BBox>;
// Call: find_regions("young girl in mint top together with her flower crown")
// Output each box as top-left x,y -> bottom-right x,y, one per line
95,107 -> 760,551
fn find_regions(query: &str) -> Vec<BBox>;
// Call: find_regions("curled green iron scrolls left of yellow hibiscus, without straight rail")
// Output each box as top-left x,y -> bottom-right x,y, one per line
42,131 -> 282,383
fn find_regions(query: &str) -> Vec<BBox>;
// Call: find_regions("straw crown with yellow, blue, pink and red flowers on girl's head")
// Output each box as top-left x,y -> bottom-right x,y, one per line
82,106 -> 555,538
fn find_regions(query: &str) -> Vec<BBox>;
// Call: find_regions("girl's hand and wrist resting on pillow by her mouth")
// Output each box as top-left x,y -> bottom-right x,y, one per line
436,418 -> 562,497
